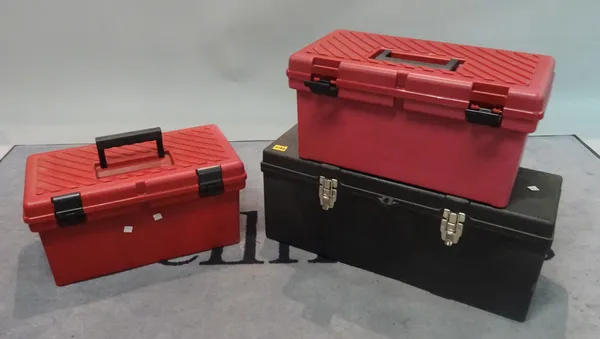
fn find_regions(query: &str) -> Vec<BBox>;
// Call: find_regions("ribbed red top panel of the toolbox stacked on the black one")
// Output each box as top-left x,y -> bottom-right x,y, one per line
300,30 -> 545,86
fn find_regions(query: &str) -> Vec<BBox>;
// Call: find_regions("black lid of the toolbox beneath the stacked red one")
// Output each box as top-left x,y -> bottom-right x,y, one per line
261,126 -> 562,240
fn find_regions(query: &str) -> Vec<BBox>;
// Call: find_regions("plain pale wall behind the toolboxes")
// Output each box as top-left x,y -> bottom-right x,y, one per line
0,0 -> 600,144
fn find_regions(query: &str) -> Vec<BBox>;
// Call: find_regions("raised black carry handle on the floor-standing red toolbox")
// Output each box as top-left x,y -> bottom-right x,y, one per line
96,127 -> 165,168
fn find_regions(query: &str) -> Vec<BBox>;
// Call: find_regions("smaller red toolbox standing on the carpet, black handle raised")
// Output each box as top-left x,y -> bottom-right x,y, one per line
23,125 -> 246,286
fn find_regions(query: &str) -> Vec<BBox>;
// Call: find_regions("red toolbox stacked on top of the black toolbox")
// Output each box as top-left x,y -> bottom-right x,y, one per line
287,30 -> 554,207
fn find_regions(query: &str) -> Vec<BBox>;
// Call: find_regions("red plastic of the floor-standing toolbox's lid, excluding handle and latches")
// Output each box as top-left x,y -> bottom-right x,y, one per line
23,125 -> 246,227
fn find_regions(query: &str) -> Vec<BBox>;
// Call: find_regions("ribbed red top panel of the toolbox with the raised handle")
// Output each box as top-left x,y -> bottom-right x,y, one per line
33,125 -> 232,196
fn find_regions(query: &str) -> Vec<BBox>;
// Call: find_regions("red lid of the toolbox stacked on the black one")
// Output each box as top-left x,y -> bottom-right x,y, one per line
287,30 -> 555,132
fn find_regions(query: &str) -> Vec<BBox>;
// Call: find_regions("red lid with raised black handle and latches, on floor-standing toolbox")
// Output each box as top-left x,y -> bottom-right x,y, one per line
23,125 -> 246,232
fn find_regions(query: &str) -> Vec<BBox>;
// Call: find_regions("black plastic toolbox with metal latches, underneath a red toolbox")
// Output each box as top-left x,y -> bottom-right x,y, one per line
261,128 -> 562,321
